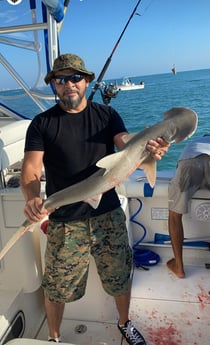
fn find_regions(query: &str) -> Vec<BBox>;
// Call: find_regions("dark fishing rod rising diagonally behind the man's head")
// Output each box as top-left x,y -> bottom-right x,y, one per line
88,0 -> 141,101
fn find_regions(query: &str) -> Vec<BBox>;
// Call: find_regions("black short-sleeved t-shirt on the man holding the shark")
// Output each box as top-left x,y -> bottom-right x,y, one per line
25,101 -> 126,221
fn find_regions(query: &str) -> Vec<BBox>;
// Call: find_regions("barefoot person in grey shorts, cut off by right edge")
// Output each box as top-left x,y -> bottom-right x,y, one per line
167,135 -> 210,278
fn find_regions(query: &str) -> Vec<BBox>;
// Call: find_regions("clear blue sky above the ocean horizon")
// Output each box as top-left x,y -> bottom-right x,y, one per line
0,0 -> 210,89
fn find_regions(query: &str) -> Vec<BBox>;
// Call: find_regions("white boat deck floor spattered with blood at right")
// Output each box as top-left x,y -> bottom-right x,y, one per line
34,253 -> 210,345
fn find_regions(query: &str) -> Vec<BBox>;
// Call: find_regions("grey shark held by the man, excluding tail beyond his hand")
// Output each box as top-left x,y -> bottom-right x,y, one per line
43,107 -> 198,210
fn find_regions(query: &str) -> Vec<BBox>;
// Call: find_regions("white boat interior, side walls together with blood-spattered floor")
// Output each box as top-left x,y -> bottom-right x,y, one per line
0,166 -> 210,345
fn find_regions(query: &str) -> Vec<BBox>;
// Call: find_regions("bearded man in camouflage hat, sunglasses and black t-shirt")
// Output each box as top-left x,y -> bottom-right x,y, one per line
21,54 -> 169,345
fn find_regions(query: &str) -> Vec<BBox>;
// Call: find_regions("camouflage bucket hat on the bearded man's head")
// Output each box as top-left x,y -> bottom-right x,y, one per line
44,54 -> 95,84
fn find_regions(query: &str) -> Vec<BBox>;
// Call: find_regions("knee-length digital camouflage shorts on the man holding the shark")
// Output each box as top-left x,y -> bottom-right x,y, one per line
42,207 -> 132,303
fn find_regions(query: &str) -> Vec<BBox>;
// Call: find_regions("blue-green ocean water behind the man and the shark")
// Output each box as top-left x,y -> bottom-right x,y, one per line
0,69 -> 210,170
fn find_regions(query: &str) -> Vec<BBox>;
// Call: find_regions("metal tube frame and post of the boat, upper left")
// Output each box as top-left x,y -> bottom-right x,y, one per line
0,1 -> 61,116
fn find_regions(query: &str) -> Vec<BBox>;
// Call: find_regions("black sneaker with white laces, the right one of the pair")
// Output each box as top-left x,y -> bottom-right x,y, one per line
118,320 -> 147,345
